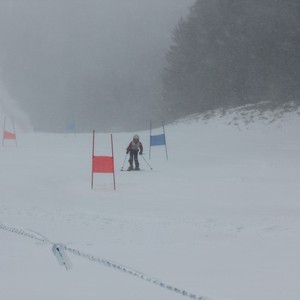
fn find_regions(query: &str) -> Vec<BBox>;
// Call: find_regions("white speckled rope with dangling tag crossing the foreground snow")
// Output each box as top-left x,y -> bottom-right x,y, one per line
0,223 -> 209,300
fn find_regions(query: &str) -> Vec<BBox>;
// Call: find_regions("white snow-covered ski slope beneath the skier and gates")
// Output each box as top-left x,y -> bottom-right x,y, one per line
0,112 -> 300,300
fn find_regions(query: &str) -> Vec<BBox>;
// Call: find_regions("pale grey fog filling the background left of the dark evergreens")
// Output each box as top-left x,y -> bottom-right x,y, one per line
0,0 -> 194,132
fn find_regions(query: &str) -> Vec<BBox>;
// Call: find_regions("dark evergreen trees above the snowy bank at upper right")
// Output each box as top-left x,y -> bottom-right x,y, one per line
163,0 -> 300,118
